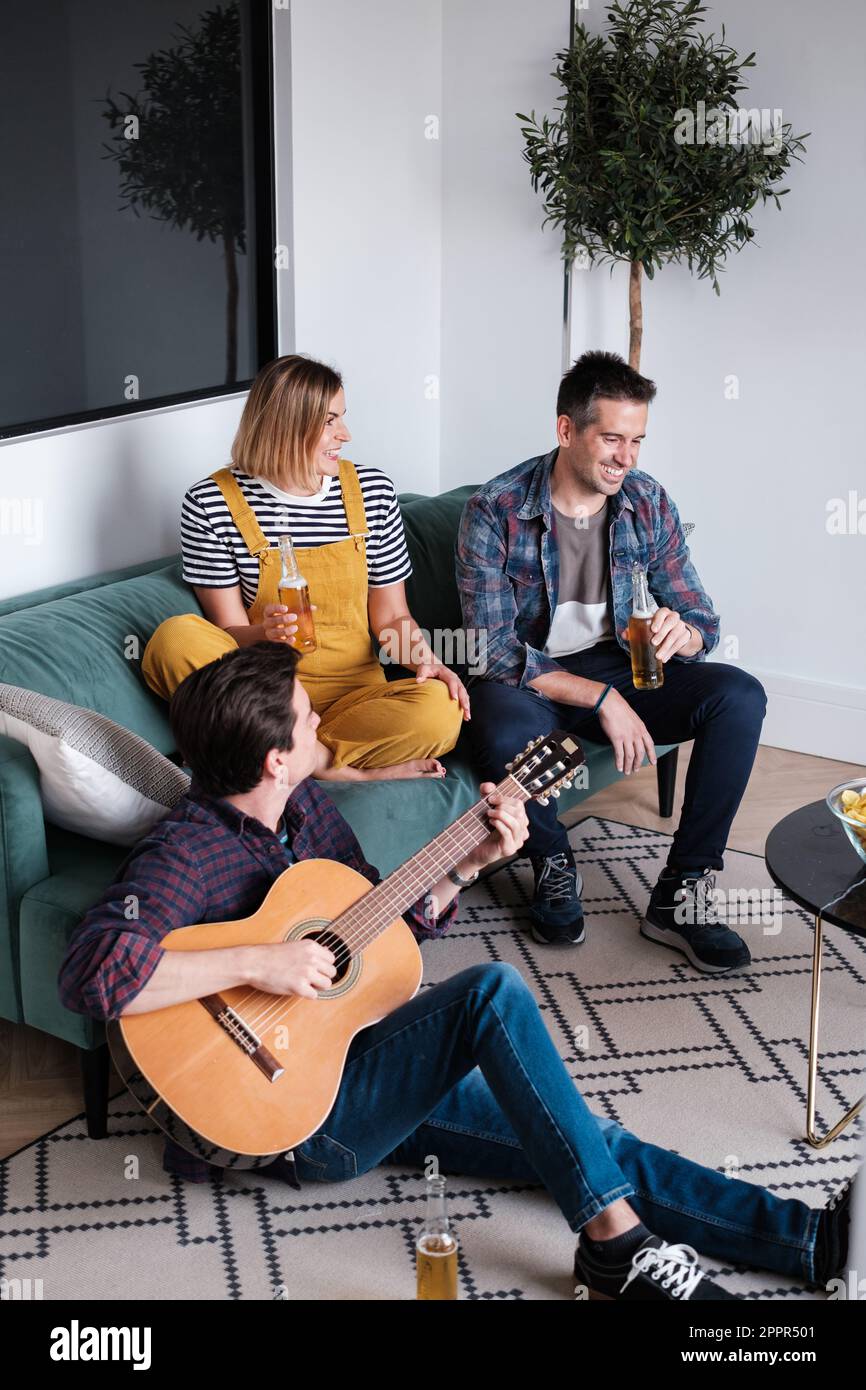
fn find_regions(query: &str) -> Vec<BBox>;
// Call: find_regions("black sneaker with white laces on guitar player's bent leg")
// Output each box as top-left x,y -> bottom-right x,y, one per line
574,1236 -> 737,1302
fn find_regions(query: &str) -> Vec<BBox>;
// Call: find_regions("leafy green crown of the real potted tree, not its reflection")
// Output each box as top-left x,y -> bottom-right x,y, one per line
517,0 -> 806,293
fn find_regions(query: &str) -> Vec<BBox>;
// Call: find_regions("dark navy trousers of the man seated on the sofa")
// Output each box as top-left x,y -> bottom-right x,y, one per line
468,641 -> 767,869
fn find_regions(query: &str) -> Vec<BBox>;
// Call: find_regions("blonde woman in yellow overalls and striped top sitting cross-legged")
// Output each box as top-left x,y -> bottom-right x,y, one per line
142,356 -> 470,781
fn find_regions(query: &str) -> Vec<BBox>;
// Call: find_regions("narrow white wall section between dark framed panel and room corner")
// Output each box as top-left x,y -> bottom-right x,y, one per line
287,0 -> 442,492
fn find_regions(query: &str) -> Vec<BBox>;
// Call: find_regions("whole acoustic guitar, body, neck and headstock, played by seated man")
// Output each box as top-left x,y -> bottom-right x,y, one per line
106,731 -> 585,1168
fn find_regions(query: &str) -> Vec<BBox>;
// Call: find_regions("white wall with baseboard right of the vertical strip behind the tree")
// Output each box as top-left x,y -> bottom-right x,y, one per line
573,0 -> 866,762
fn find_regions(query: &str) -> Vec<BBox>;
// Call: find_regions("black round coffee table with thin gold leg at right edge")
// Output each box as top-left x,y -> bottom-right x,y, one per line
765,801 -> 866,1148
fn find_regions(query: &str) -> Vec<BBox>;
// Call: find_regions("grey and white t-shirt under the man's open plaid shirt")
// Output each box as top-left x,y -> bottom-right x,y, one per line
545,505 -> 613,656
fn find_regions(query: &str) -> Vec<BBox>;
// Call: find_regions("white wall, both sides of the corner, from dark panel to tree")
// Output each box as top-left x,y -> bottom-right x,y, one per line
287,0 -> 569,492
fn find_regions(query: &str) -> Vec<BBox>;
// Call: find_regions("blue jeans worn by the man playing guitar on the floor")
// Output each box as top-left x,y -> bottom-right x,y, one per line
295,963 -> 819,1279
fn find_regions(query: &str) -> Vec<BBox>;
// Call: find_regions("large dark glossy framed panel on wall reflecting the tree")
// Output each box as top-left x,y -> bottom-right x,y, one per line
0,0 -> 277,438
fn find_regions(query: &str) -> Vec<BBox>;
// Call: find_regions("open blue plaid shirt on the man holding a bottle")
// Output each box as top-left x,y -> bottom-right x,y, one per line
457,449 -> 719,685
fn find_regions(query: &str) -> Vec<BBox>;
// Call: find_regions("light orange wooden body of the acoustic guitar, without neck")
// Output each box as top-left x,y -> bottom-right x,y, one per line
107,859 -> 421,1168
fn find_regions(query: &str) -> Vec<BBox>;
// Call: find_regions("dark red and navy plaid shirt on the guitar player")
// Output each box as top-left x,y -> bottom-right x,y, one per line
58,780 -> 457,1182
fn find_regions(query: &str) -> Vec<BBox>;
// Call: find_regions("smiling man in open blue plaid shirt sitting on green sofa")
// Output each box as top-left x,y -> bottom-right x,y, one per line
457,352 -> 766,974
